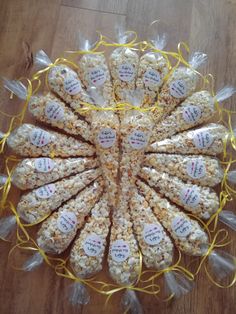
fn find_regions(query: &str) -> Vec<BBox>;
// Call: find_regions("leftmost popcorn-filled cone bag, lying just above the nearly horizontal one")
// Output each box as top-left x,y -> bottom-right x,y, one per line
7,123 -> 95,157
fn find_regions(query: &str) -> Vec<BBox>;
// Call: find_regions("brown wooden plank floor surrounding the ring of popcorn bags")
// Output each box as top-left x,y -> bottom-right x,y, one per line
0,0 -> 236,314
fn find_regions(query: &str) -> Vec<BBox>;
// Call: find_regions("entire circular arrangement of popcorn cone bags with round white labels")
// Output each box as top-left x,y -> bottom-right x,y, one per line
0,31 -> 235,310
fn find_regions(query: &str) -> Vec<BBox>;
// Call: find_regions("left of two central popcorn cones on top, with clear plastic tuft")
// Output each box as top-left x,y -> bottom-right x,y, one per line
90,87 -> 120,206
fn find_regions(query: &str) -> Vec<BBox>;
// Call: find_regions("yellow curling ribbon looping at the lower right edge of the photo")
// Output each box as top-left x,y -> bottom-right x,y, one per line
191,229 -> 236,288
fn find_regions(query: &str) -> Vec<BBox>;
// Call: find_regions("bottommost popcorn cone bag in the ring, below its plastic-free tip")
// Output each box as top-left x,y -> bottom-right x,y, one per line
108,208 -> 141,285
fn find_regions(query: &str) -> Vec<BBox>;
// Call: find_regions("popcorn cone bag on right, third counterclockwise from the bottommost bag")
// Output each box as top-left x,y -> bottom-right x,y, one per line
139,167 -> 220,219
